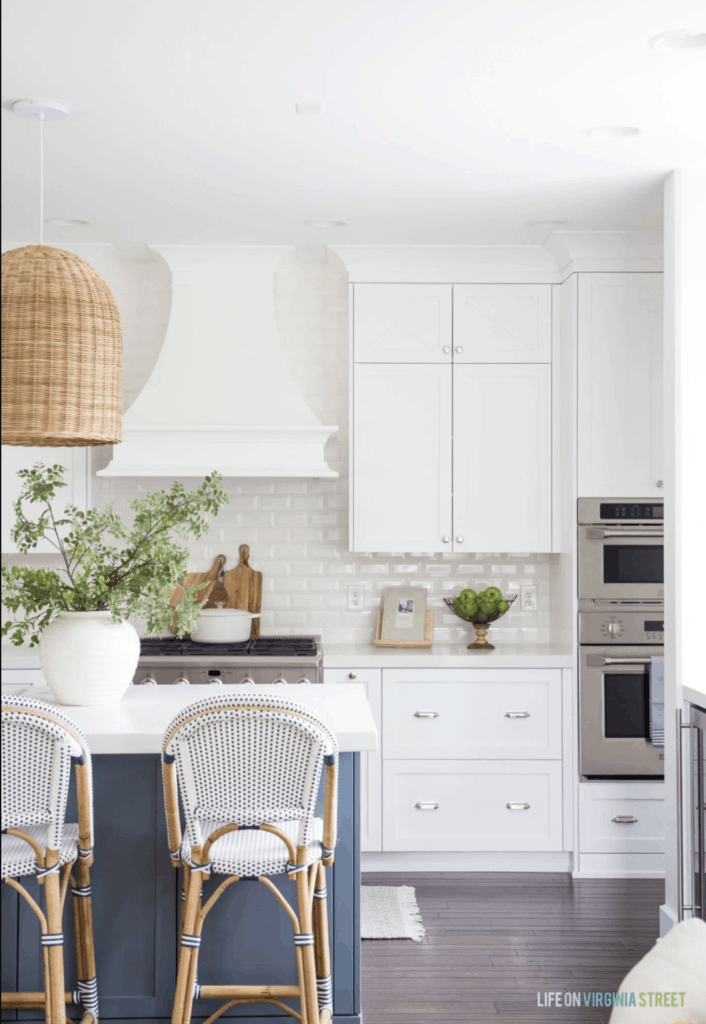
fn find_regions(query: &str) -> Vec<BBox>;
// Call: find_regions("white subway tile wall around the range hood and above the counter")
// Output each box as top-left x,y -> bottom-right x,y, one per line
8,247 -> 557,643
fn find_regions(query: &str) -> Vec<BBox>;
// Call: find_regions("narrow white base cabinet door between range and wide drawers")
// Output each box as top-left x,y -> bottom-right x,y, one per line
324,669 -> 382,853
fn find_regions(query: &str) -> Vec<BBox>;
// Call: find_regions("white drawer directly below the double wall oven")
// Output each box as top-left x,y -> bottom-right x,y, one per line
579,782 -> 665,853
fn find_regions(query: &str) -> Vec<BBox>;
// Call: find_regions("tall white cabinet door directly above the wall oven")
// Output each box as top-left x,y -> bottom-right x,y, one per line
578,273 -> 664,498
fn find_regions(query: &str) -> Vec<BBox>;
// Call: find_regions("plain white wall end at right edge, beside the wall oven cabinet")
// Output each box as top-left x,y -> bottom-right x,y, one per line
662,170 -> 706,934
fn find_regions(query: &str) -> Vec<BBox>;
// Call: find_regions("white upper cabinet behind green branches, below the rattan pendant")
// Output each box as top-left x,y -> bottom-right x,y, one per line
1,444 -> 88,554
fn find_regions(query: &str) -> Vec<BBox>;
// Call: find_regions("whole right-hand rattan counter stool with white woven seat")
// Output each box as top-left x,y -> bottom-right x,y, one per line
162,690 -> 338,1024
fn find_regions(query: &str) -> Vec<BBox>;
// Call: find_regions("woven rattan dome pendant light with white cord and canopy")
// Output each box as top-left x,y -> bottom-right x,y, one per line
1,100 -> 123,447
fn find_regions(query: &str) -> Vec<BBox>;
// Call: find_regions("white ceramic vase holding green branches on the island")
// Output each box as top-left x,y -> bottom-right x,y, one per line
39,611 -> 139,706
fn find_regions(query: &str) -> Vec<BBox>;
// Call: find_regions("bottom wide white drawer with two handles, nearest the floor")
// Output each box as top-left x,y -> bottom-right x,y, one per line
382,761 -> 562,852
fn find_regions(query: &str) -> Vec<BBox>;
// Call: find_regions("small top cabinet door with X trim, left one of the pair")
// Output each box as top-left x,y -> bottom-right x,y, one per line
354,285 -> 452,362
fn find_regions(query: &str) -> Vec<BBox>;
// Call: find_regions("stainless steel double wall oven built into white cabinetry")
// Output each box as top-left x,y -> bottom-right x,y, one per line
578,499 -> 664,778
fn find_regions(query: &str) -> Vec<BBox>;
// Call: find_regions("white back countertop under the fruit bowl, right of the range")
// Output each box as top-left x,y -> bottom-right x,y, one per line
324,643 -> 574,669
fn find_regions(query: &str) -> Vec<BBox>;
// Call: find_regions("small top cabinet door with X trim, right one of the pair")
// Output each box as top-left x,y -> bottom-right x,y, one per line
453,285 -> 551,362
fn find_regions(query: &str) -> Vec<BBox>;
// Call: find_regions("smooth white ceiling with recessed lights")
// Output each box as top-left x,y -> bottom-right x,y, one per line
2,0 -> 706,246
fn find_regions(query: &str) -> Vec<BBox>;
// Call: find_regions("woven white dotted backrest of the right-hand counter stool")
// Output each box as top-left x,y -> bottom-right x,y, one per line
163,690 -> 337,846
